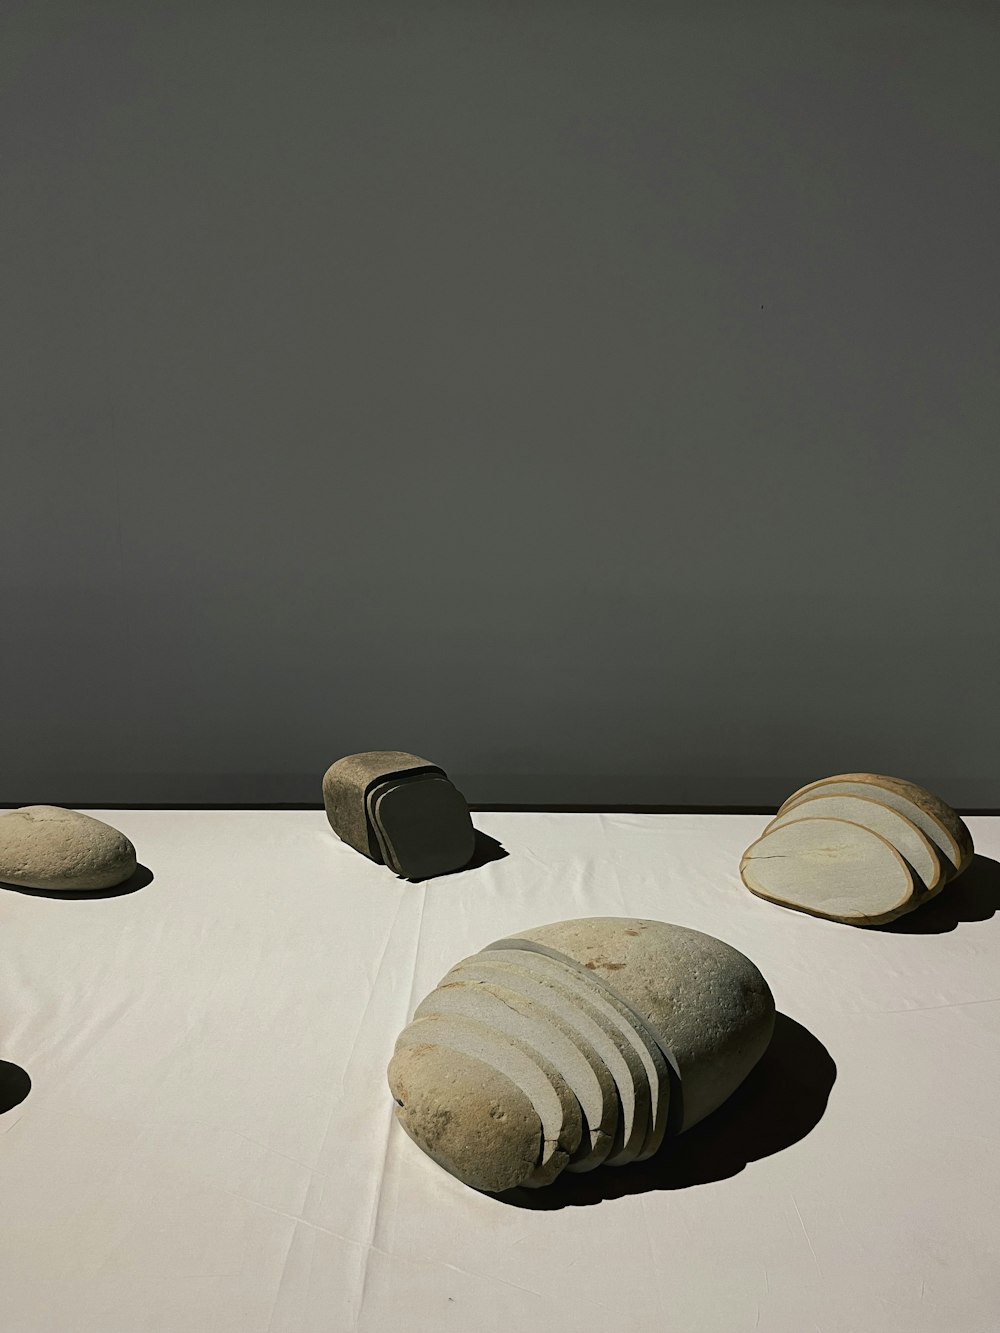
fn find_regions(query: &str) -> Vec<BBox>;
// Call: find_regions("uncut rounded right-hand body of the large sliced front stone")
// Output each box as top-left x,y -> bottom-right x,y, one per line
511,922 -> 778,1132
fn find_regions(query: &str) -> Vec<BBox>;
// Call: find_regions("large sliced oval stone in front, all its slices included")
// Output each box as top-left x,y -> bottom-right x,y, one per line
388,917 -> 775,1193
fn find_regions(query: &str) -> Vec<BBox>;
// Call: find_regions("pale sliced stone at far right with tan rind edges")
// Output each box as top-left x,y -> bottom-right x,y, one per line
740,773 -> 973,925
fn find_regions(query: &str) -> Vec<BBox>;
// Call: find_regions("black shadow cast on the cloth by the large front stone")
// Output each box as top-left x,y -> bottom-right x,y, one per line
493,1013 -> 837,1210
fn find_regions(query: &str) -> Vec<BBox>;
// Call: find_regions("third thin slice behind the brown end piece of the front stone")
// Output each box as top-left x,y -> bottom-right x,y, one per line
445,950 -> 649,1166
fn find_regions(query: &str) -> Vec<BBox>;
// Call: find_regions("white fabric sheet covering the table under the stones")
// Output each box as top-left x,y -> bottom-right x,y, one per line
0,810 -> 1000,1333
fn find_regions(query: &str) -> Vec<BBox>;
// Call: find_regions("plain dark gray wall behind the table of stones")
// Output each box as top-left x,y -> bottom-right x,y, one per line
0,0 -> 1000,806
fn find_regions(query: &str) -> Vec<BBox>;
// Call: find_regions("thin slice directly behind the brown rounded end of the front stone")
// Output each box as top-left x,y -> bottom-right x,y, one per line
396,1013 -> 583,1188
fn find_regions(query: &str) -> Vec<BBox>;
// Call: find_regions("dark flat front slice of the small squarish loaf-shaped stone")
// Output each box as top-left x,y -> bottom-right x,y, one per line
369,774 -> 476,880
